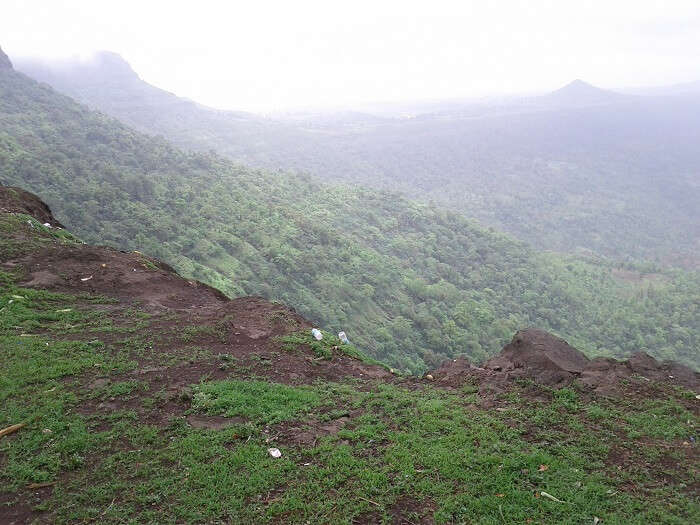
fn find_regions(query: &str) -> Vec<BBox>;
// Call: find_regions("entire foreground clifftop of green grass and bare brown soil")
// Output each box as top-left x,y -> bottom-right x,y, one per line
0,196 -> 700,525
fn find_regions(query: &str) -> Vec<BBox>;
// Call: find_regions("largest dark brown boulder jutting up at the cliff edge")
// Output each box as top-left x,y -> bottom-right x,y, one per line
484,328 -> 589,385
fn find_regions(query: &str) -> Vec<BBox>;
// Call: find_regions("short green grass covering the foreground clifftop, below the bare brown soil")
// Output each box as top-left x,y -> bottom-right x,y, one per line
0,222 -> 700,524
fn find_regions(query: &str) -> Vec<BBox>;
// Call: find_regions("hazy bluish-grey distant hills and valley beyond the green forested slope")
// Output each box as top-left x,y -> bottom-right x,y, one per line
15,54 -> 700,267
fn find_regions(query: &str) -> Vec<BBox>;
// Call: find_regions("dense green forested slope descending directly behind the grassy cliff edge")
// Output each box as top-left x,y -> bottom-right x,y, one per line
0,59 -> 700,371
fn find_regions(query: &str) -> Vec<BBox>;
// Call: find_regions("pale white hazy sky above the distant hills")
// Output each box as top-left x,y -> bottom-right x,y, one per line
0,0 -> 700,111
